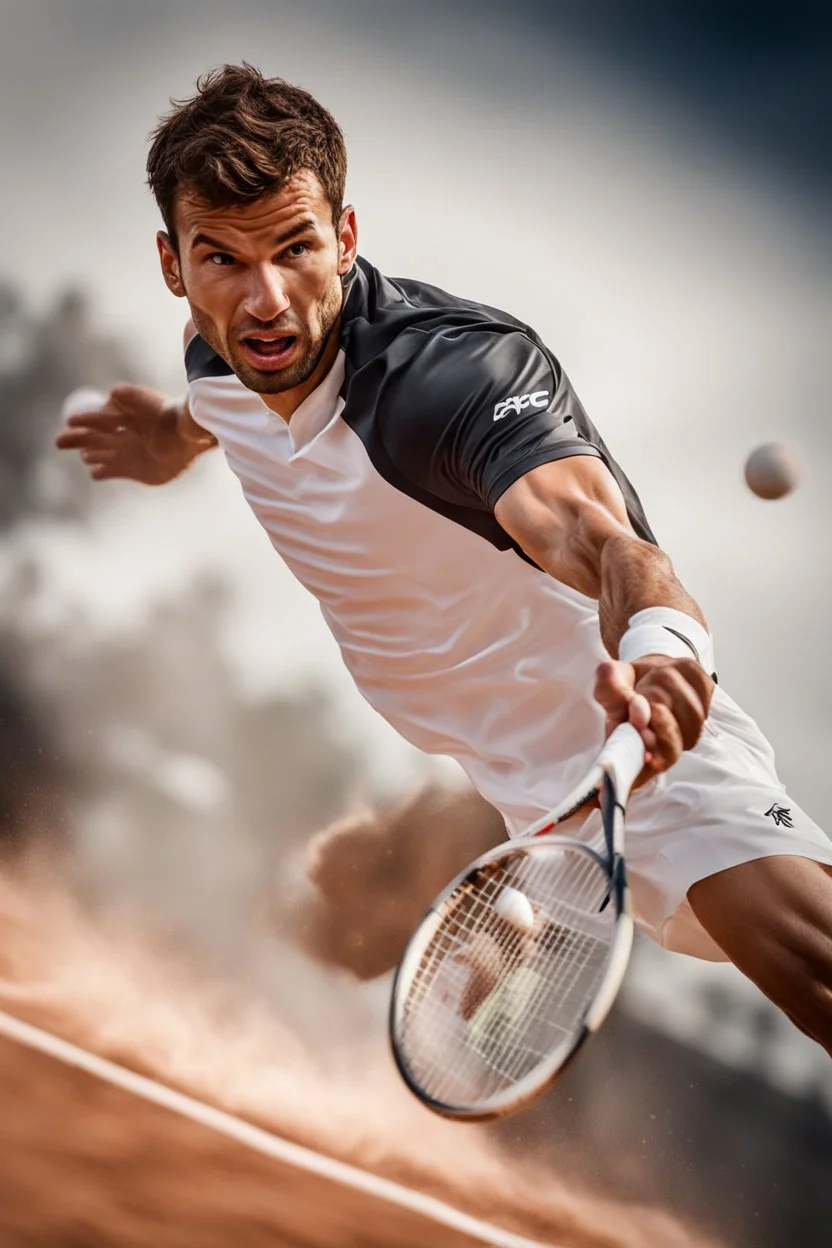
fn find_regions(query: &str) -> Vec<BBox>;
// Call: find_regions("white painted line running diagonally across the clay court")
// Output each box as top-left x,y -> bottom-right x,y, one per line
0,1011 -> 566,1248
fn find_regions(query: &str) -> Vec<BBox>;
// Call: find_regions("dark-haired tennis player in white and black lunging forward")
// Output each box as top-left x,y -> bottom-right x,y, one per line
57,66 -> 832,1051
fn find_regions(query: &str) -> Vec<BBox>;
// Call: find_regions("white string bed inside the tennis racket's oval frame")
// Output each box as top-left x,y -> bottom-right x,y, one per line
398,845 -> 616,1104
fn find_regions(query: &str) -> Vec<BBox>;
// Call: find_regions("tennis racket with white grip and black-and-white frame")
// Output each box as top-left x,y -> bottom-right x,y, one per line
390,724 -> 645,1121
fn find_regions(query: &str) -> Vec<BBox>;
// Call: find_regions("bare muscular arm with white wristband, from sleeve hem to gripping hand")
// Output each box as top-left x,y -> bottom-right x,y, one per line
494,456 -> 713,771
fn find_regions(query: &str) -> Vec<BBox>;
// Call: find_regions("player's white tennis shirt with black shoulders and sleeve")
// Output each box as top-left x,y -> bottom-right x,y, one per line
186,260 -> 654,831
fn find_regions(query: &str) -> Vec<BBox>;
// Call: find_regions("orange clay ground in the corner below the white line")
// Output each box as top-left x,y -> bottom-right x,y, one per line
0,1041 -> 521,1248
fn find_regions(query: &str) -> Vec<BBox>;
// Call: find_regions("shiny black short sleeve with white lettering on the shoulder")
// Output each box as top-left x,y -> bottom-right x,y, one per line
384,328 -> 604,510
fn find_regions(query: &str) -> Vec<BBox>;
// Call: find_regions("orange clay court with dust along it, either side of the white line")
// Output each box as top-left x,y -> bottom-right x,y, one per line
0,881 -> 706,1248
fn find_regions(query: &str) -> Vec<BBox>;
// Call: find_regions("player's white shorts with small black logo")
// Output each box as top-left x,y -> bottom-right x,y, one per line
570,686 -> 832,962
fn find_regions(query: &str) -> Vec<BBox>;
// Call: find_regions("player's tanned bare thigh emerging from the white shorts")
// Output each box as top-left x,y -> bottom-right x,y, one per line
687,855 -> 832,1055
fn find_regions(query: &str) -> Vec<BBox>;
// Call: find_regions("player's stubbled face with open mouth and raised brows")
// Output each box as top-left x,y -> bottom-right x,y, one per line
158,170 -> 356,394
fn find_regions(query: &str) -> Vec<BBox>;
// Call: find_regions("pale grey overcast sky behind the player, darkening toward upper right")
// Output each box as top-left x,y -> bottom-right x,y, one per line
0,0 -> 832,816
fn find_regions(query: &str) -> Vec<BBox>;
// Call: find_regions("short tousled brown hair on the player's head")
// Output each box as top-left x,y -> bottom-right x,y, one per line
147,62 -> 347,242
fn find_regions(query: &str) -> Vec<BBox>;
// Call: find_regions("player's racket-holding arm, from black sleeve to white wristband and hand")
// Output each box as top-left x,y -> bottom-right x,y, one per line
359,326 -> 713,771
